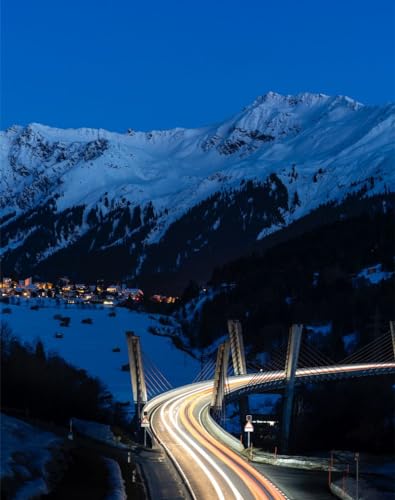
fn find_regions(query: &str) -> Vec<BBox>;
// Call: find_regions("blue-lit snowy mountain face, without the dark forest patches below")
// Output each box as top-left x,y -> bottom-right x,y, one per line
0,92 -> 395,284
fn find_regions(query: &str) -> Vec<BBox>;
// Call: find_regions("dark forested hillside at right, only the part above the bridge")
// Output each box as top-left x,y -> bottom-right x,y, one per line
178,201 -> 395,359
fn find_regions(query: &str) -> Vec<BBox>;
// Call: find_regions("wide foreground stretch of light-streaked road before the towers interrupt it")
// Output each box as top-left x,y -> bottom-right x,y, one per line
150,382 -> 285,500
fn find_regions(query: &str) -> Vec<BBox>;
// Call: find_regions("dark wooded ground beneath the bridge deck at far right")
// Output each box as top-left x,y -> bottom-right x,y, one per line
291,375 -> 395,453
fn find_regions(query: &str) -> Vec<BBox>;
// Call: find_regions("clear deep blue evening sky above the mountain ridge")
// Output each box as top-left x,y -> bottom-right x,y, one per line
1,0 -> 395,131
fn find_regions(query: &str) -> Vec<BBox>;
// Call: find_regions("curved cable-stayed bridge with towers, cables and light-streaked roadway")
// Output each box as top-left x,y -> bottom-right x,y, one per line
129,321 -> 395,500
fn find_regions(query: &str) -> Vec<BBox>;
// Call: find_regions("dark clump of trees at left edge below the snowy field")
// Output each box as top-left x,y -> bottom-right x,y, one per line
0,322 -> 125,425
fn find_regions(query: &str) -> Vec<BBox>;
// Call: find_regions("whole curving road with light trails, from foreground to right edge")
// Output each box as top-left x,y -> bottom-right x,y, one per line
144,363 -> 395,500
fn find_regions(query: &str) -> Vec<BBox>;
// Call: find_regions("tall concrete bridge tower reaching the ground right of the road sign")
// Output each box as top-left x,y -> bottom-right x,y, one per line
280,325 -> 303,454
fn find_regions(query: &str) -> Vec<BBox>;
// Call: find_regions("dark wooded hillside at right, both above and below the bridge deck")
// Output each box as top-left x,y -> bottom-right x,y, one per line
177,203 -> 395,453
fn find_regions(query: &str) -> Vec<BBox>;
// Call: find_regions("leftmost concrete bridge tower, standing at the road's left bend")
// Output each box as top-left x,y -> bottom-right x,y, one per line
126,332 -> 148,420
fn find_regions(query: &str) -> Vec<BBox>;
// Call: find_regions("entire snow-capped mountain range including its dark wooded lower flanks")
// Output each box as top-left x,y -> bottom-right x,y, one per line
0,92 -> 395,290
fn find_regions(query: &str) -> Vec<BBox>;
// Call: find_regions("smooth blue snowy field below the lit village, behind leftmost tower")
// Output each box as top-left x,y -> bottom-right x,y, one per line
3,299 -> 199,402
